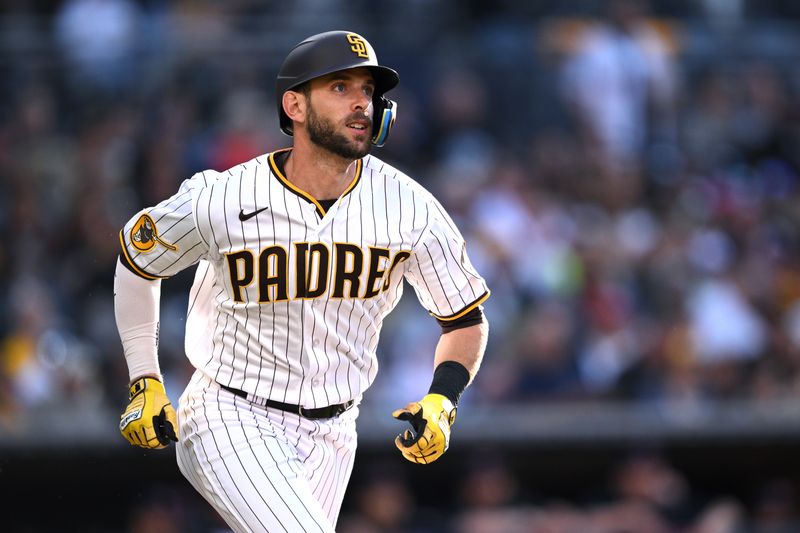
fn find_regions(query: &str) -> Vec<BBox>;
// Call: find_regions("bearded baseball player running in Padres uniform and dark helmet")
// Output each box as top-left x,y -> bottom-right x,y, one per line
114,31 -> 489,532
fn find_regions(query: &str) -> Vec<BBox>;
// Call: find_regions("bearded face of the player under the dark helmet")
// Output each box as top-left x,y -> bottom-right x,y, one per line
306,67 -> 375,160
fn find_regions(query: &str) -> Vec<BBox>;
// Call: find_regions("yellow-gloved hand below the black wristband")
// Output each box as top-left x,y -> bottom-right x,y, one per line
392,394 -> 456,464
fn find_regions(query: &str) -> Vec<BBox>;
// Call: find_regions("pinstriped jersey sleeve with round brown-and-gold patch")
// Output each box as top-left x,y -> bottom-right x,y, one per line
119,174 -> 208,280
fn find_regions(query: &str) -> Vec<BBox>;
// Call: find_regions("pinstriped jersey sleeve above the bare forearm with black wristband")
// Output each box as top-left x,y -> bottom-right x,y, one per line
405,200 -> 490,322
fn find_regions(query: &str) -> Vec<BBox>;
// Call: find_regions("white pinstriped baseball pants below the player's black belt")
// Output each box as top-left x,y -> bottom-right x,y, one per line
177,371 -> 358,533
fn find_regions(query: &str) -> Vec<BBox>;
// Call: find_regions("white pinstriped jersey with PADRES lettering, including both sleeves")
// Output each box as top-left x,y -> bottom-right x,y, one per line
120,150 -> 489,408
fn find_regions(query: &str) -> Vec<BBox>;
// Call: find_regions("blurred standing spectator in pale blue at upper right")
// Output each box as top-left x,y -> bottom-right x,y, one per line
563,0 -> 677,168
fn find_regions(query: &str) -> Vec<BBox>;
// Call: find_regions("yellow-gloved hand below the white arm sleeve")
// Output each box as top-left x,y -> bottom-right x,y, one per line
119,377 -> 178,448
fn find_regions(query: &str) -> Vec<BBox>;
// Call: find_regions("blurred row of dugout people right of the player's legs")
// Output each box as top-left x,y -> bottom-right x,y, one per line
339,451 -> 798,533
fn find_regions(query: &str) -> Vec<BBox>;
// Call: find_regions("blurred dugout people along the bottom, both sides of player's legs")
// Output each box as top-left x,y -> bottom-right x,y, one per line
126,449 -> 800,533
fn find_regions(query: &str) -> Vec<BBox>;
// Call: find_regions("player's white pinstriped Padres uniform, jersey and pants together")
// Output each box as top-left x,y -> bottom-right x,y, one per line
120,149 -> 489,531
